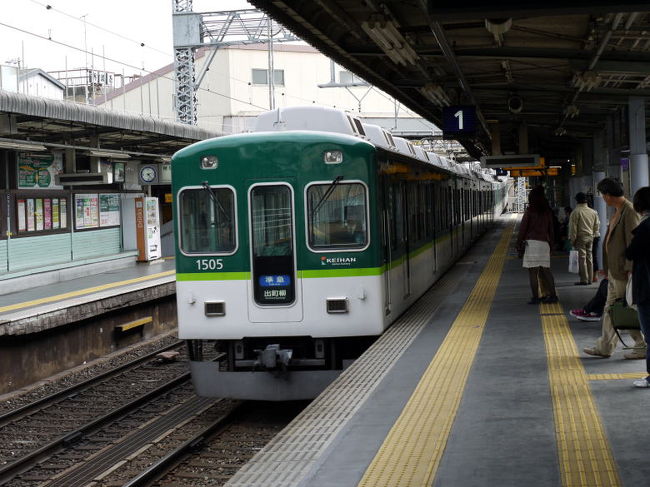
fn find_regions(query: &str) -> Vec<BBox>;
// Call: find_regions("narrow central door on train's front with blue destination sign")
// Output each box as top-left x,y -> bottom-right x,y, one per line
248,183 -> 303,322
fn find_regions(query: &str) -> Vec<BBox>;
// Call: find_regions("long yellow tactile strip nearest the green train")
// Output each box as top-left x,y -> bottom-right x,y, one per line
359,225 -> 513,487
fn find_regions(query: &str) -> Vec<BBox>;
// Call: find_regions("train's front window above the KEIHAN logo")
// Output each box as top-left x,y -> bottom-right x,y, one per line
307,183 -> 368,250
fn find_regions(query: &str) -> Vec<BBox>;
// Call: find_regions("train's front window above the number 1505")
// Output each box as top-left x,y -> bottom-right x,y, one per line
180,188 -> 236,254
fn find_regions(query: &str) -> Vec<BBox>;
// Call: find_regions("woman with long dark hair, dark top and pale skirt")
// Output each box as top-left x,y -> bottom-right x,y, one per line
517,186 -> 558,304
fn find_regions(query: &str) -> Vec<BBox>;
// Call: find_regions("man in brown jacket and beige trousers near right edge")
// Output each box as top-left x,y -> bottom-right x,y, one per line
584,178 -> 646,360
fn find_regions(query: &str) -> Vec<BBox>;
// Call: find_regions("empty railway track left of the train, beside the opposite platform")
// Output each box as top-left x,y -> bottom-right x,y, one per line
0,342 -> 189,484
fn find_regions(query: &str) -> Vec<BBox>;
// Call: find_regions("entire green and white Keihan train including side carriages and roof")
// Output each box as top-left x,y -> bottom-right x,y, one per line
172,107 -> 506,400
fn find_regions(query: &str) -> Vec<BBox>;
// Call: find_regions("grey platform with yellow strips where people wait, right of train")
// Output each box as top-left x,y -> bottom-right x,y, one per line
227,216 -> 650,487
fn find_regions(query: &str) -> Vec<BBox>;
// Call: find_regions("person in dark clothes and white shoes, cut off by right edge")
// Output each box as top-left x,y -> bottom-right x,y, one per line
625,186 -> 650,387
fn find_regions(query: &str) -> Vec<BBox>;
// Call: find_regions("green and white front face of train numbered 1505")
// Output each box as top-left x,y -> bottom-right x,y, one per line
172,132 -> 386,400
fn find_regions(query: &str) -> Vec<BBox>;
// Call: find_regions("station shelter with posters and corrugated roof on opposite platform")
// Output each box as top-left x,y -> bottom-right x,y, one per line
0,90 -> 218,292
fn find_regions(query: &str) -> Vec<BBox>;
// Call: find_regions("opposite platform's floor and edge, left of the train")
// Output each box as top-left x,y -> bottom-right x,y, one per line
0,259 -> 176,335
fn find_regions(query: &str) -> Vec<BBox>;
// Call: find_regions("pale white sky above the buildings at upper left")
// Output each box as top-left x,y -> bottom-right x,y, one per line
0,0 -> 253,76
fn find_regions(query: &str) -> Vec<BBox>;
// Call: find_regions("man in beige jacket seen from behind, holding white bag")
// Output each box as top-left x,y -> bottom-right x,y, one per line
569,193 -> 600,286
